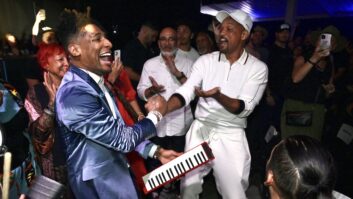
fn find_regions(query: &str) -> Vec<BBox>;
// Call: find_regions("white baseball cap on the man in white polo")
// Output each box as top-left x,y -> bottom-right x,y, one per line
216,10 -> 252,32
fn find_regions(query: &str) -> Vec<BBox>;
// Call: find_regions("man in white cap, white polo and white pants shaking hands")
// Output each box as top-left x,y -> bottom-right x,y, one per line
168,10 -> 268,199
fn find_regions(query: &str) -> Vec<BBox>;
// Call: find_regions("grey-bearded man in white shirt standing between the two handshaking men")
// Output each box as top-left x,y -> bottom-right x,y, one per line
137,27 -> 193,151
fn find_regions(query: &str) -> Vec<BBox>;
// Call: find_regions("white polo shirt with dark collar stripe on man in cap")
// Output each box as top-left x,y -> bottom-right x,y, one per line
176,50 -> 268,128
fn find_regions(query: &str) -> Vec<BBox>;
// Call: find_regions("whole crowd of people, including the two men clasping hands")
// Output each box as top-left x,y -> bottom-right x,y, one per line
0,5 -> 353,199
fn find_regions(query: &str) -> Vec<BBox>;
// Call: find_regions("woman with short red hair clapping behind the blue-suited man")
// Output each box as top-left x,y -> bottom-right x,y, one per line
25,43 -> 71,198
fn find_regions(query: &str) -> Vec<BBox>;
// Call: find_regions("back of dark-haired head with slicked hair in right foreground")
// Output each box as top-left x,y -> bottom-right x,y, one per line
265,135 -> 336,199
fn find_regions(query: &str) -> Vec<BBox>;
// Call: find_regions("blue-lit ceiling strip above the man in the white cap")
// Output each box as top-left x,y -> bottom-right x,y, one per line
201,0 -> 353,21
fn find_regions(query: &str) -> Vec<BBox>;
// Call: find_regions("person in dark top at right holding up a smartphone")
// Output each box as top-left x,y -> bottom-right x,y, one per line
281,27 -> 337,140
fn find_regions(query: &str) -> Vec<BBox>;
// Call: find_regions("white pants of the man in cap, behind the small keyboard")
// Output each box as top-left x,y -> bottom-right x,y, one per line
181,120 -> 251,199
